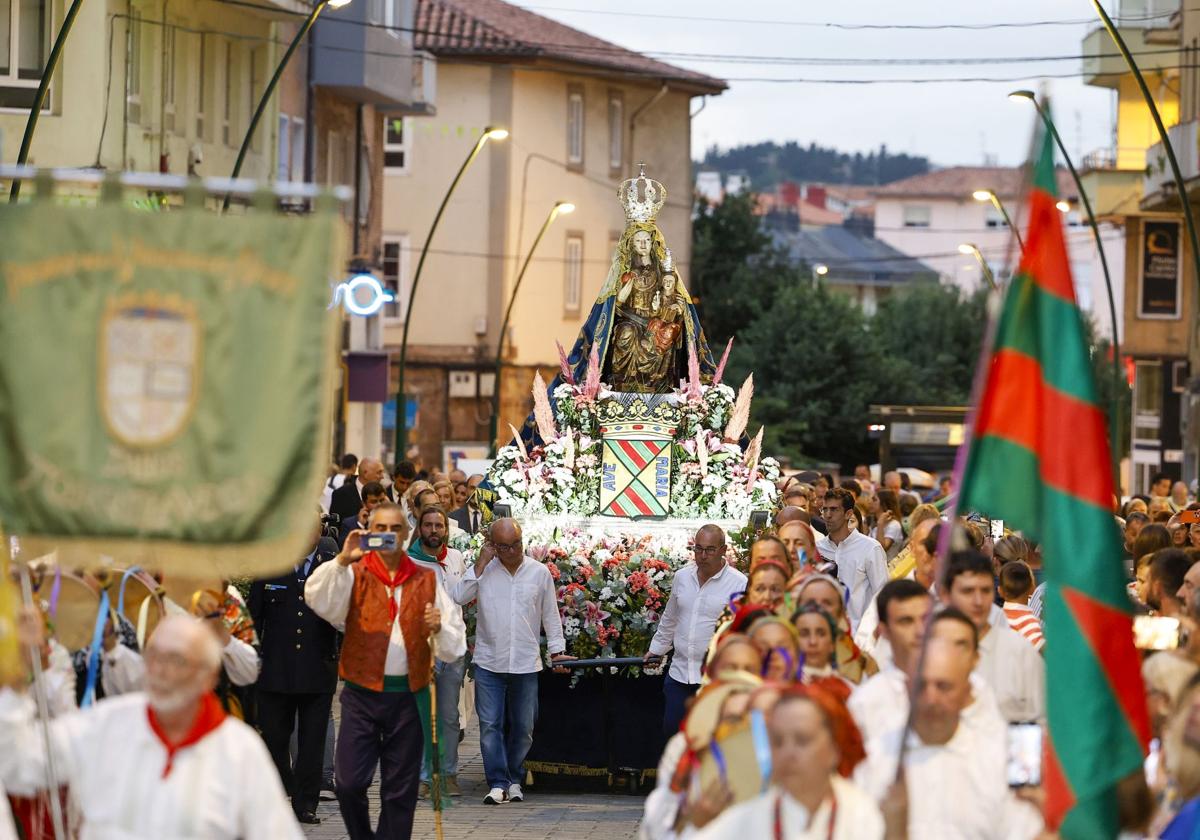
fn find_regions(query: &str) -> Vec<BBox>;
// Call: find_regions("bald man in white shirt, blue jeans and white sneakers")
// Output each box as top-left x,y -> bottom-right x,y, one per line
457,518 -> 574,805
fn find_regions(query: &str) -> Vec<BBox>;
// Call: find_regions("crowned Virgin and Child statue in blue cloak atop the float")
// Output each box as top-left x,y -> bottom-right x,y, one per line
522,169 -> 716,440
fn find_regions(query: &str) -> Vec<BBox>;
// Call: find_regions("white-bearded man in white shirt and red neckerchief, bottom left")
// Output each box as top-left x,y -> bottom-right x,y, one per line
0,614 -> 302,840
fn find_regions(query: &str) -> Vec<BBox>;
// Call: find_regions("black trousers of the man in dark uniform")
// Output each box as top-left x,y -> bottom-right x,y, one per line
258,690 -> 334,814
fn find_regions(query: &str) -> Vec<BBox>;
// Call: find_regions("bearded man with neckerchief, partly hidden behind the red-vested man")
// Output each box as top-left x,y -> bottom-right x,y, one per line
408,505 -> 467,798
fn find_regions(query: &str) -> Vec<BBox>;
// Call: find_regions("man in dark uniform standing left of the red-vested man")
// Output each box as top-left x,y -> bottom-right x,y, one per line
247,516 -> 340,823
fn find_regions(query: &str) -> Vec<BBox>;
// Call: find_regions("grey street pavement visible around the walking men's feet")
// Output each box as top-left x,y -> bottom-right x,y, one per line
302,721 -> 644,840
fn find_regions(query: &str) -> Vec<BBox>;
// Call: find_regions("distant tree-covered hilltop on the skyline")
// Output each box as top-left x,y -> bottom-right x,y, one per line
701,142 -> 929,190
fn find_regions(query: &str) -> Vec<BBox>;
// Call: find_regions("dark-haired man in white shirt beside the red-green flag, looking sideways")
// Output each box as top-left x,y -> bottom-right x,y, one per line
940,551 -> 1046,724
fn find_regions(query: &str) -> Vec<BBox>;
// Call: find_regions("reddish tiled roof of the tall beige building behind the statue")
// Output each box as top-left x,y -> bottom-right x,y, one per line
413,0 -> 727,94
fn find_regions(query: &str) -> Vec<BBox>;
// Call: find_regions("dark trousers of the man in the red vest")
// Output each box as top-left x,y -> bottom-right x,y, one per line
334,684 -> 425,840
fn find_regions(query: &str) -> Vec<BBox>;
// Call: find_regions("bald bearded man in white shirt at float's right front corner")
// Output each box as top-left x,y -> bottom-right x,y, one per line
646,524 -> 746,738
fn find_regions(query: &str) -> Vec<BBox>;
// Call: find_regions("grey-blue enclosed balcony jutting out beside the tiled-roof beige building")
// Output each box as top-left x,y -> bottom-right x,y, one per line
312,2 -> 437,115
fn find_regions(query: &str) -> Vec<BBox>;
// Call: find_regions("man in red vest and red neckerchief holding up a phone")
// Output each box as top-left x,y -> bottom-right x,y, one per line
305,503 -> 467,840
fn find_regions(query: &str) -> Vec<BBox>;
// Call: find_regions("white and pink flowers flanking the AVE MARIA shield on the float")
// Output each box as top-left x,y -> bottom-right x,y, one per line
491,347 -> 780,521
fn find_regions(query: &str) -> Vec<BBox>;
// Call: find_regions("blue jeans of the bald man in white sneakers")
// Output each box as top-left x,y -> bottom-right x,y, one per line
475,665 -> 538,790
